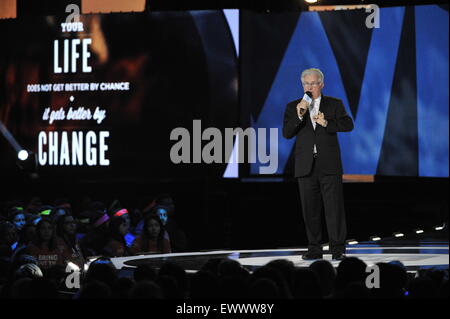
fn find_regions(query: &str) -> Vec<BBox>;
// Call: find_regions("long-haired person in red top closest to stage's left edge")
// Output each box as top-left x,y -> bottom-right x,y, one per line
130,214 -> 171,254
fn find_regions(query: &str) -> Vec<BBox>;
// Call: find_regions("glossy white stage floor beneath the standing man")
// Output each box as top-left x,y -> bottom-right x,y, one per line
100,239 -> 449,276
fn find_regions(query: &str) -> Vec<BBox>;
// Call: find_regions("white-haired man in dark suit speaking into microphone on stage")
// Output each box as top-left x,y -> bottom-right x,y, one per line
283,69 -> 353,260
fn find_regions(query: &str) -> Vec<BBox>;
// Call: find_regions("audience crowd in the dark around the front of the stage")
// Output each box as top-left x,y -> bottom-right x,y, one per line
0,194 -> 448,300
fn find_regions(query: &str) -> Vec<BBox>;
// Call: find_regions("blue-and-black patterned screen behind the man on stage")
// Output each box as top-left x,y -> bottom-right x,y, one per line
240,5 -> 449,177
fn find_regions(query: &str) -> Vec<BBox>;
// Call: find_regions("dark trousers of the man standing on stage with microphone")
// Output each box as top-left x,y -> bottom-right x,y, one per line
298,159 -> 347,254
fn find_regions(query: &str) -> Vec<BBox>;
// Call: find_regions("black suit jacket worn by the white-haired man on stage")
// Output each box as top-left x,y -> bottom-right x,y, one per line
283,95 -> 353,177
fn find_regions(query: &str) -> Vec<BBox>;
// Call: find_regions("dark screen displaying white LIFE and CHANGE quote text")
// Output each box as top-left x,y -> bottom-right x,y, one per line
0,10 -> 239,181
